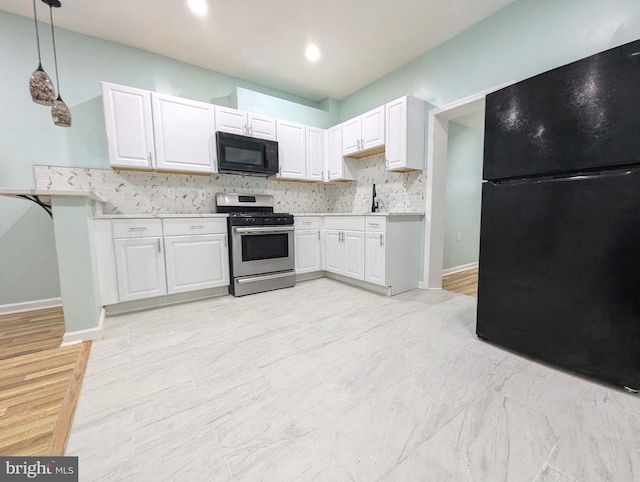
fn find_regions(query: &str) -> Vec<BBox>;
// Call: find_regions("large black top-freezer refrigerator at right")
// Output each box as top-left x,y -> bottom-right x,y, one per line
476,40 -> 640,391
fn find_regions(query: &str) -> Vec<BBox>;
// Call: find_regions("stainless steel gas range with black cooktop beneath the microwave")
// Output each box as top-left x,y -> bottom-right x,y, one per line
216,193 -> 296,296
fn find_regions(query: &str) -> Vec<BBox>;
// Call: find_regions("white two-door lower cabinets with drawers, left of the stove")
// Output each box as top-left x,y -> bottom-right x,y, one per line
112,218 -> 229,302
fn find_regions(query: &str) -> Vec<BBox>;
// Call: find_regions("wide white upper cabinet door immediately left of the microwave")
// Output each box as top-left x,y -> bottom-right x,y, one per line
151,93 -> 216,172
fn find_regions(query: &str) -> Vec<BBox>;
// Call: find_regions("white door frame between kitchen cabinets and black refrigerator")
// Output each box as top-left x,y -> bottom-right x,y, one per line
422,81 -> 515,289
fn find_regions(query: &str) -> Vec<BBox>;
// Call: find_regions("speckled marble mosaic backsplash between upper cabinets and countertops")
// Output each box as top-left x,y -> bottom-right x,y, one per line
34,154 -> 425,214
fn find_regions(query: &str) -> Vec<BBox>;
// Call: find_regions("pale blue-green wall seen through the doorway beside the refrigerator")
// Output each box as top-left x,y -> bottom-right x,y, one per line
442,122 -> 484,269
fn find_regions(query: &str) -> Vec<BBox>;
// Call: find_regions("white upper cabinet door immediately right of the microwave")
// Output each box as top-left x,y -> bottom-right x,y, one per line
277,119 -> 306,180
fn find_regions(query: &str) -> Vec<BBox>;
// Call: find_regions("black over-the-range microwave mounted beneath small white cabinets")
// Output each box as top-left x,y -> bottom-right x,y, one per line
216,131 -> 278,176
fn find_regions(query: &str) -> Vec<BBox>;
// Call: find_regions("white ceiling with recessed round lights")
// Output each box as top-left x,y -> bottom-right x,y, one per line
0,0 -> 514,100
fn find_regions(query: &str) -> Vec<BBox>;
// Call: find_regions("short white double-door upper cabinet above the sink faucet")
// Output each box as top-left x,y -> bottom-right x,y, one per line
342,106 -> 385,157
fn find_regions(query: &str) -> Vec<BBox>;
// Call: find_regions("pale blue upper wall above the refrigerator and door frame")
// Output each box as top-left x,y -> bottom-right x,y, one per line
340,0 -> 640,120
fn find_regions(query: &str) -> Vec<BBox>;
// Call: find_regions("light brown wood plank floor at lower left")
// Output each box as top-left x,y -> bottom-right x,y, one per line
0,308 -> 91,456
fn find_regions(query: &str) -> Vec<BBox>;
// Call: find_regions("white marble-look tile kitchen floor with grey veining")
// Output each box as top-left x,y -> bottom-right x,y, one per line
66,279 -> 640,482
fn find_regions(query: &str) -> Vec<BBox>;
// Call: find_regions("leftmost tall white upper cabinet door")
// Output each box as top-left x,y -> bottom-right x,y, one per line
102,82 -> 155,169
